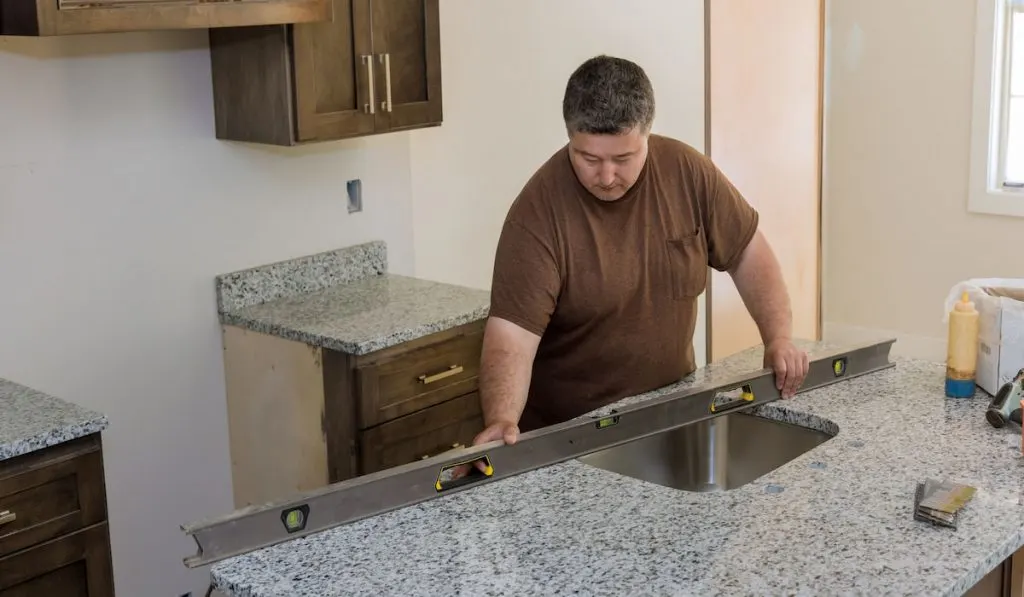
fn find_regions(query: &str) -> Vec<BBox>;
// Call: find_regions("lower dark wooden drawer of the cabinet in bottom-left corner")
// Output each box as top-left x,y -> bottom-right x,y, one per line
0,522 -> 114,597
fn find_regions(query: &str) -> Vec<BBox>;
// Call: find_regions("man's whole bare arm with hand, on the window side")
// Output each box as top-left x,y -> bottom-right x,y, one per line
728,230 -> 809,397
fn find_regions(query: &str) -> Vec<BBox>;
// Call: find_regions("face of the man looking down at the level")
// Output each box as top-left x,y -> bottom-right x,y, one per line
569,129 -> 647,201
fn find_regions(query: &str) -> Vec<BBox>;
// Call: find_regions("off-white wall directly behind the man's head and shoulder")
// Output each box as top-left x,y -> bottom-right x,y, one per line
411,0 -> 706,365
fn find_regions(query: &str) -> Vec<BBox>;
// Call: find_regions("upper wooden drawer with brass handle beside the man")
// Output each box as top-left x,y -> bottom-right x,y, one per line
355,326 -> 483,429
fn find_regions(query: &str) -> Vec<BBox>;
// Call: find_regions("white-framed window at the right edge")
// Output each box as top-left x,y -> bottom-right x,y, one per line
968,0 -> 1024,217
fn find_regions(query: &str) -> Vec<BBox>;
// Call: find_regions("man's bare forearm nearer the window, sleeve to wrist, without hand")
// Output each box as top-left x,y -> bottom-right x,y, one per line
729,231 -> 793,346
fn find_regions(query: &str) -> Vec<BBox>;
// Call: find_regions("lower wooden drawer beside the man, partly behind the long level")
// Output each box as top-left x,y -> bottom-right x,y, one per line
359,392 -> 483,474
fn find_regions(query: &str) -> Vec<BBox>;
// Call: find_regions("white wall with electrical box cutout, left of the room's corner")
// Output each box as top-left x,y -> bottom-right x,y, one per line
0,32 -> 413,597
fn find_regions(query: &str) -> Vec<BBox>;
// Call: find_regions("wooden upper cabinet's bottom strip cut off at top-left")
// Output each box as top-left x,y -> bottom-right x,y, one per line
0,0 -> 331,36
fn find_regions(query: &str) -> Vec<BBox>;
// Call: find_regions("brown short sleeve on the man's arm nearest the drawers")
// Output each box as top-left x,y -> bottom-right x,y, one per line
489,220 -> 561,336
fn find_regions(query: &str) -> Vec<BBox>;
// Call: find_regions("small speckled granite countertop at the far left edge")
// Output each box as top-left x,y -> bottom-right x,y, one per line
0,378 -> 108,460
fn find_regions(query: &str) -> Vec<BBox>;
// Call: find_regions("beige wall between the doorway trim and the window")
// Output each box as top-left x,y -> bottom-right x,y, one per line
823,0 -> 1024,359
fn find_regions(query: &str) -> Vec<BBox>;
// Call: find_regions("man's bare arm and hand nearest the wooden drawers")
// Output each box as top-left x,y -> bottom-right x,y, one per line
473,316 -> 541,444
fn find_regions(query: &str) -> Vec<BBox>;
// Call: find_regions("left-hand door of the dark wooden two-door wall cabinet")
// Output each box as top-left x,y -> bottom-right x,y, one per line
293,0 -> 379,141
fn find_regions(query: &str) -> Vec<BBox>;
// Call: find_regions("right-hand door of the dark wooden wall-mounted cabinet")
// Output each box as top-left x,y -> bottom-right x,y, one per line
372,0 -> 441,132
